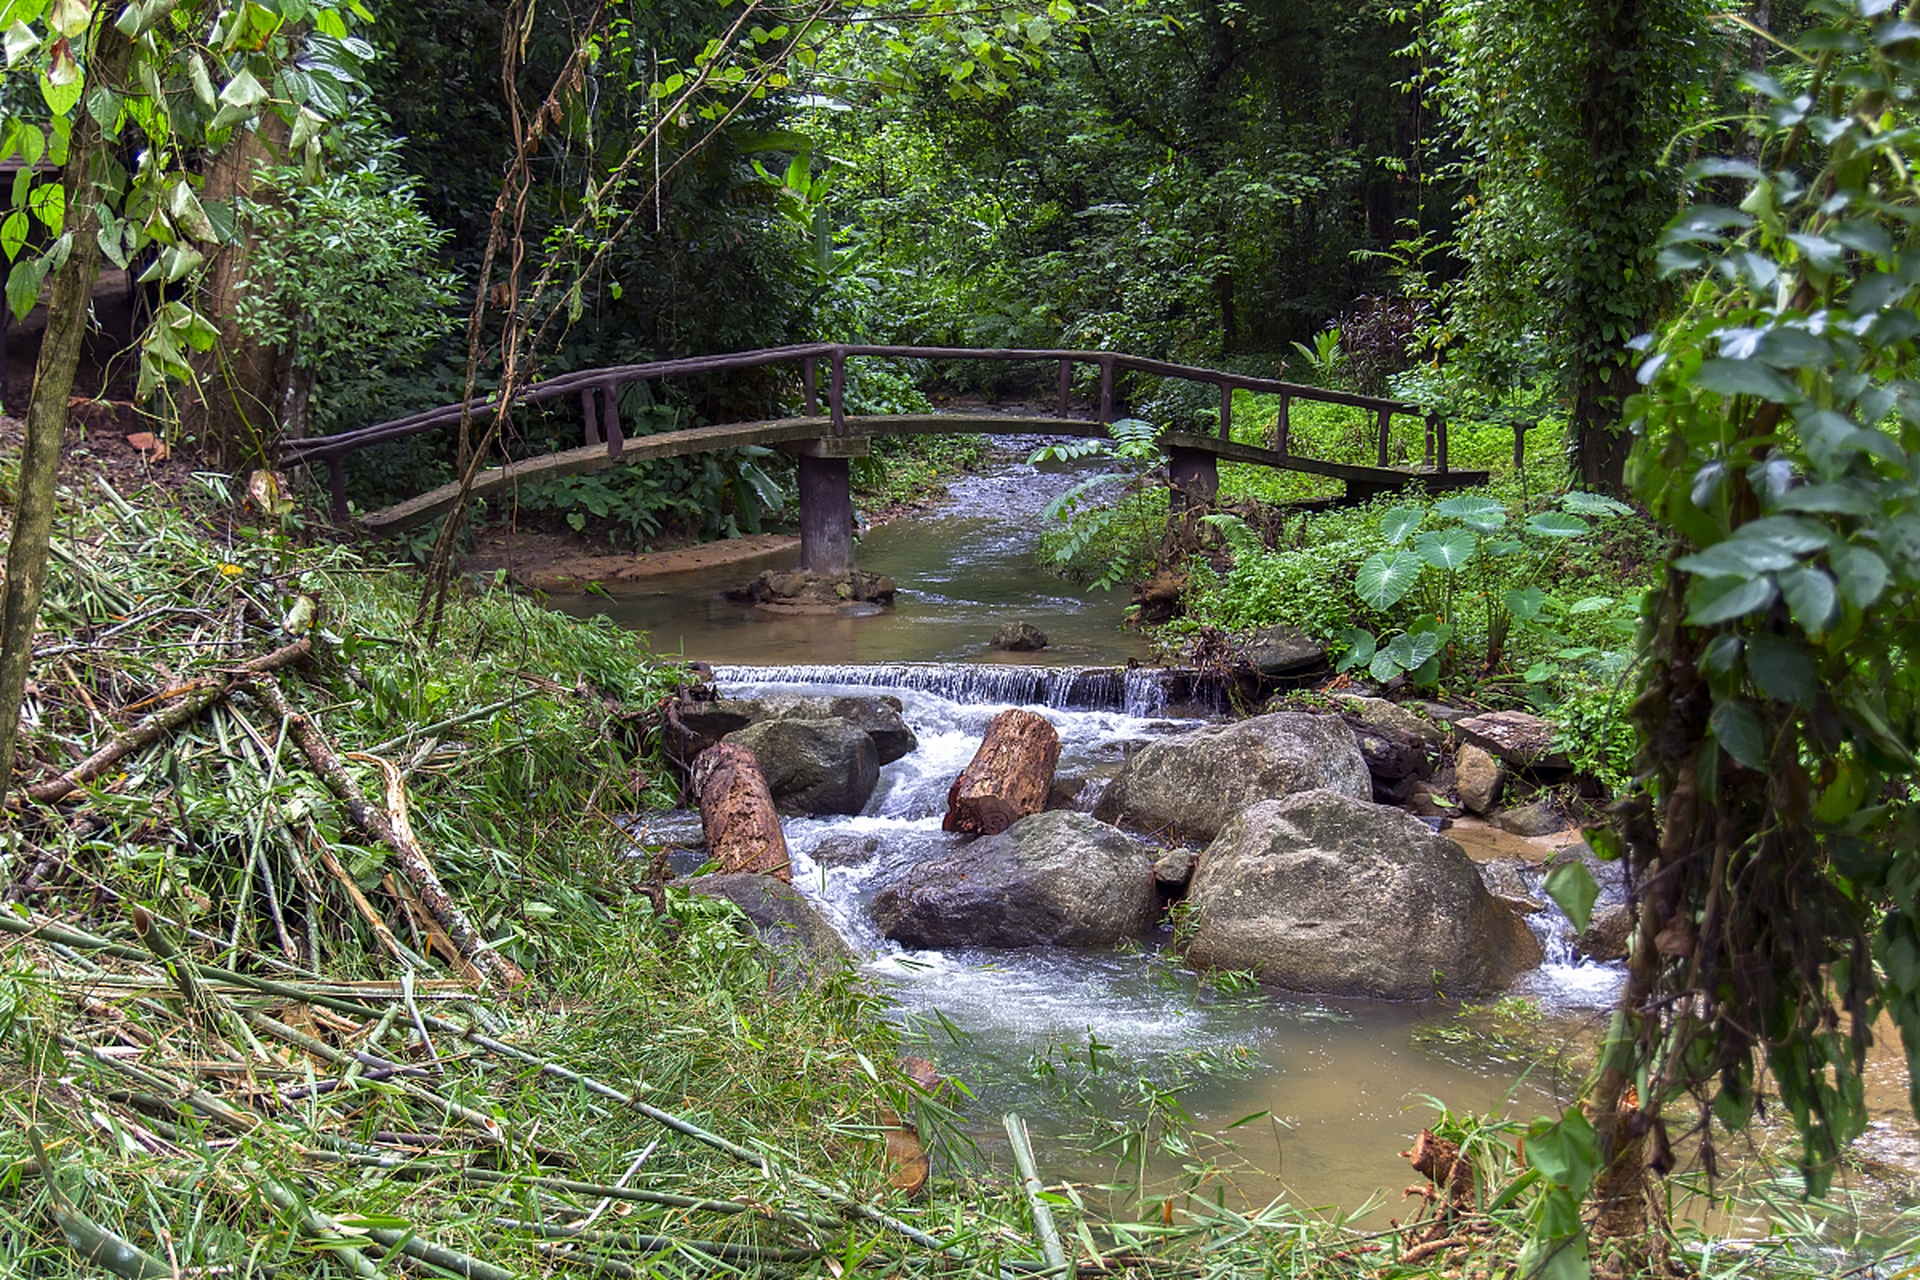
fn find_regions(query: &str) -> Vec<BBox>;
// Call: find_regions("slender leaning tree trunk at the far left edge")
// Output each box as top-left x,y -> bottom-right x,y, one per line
0,20 -> 132,812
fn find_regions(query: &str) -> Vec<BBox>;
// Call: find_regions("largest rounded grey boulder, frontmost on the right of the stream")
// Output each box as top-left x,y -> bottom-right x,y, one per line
1187,791 -> 1542,1000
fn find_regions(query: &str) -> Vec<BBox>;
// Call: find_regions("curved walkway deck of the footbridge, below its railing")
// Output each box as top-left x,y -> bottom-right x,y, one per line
363,413 -> 1486,533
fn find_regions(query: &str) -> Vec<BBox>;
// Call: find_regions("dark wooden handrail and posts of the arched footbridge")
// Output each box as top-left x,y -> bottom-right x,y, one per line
280,342 -> 1448,520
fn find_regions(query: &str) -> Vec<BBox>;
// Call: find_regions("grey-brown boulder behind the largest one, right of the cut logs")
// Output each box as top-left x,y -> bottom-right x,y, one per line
1092,712 -> 1373,842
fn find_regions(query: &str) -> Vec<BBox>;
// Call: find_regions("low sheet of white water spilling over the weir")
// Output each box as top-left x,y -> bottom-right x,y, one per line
714,662 -> 1225,720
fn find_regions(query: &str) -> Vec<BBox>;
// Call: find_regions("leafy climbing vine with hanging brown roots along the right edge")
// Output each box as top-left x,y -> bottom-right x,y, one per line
1528,0 -> 1920,1274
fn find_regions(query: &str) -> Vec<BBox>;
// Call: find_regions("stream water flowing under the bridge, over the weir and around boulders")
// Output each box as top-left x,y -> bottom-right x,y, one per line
564,452 -> 1619,1215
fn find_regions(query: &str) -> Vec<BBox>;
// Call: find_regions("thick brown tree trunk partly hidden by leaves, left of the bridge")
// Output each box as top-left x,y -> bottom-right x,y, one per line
180,111 -> 286,470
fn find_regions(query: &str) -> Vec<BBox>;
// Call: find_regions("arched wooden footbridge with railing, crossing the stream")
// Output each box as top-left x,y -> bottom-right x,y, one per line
282,344 -> 1486,574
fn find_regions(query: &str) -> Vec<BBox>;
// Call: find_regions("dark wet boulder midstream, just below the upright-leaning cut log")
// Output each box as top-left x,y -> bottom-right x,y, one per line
874,810 -> 1158,946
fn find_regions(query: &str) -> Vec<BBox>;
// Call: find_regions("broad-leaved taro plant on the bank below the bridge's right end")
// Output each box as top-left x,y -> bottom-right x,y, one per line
1338,491 -> 1630,685
